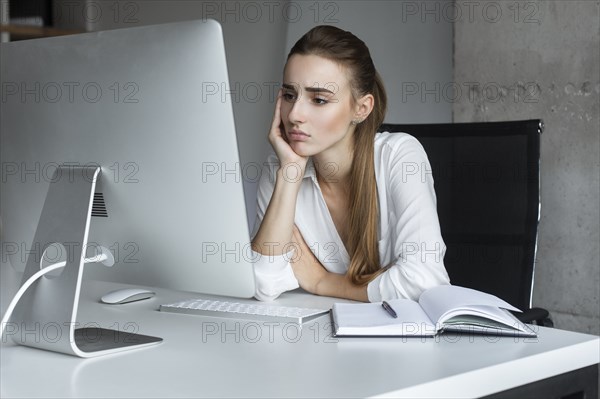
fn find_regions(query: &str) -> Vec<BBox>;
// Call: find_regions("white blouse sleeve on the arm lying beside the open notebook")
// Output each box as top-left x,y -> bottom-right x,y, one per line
367,134 -> 450,302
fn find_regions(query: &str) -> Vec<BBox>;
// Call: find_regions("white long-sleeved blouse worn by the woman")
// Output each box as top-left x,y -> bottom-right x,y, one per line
253,132 -> 450,302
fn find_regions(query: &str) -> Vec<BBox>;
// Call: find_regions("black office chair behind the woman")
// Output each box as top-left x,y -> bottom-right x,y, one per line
379,119 -> 553,326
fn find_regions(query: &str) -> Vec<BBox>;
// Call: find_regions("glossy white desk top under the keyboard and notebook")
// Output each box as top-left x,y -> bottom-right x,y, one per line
0,272 -> 600,398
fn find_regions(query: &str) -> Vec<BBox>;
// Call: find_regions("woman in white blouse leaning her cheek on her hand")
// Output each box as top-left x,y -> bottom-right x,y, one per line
252,26 -> 449,302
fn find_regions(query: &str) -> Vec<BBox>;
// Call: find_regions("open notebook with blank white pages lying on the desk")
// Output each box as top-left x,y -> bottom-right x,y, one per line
331,285 -> 536,337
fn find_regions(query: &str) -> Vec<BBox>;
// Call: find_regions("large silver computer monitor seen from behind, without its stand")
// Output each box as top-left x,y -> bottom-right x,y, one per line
0,20 -> 254,297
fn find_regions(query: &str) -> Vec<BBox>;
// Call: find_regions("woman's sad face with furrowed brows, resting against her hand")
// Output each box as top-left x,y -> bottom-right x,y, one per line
281,54 -> 356,156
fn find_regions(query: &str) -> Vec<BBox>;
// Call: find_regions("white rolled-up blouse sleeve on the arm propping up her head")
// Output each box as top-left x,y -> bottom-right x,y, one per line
252,154 -> 300,301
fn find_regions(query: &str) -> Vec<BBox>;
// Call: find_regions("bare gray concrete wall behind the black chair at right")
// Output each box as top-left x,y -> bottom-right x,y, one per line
452,0 -> 600,334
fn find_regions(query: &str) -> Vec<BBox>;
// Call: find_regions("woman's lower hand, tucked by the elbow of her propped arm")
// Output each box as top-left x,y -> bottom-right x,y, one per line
290,226 -> 328,294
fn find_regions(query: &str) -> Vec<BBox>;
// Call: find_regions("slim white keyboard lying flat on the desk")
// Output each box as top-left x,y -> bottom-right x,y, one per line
160,298 -> 329,324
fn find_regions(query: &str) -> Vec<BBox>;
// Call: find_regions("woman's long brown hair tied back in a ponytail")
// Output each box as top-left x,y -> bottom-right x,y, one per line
288,25 -> 387,284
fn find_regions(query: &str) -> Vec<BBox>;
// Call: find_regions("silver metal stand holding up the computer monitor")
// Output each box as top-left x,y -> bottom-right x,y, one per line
10,166 -> 162,357
